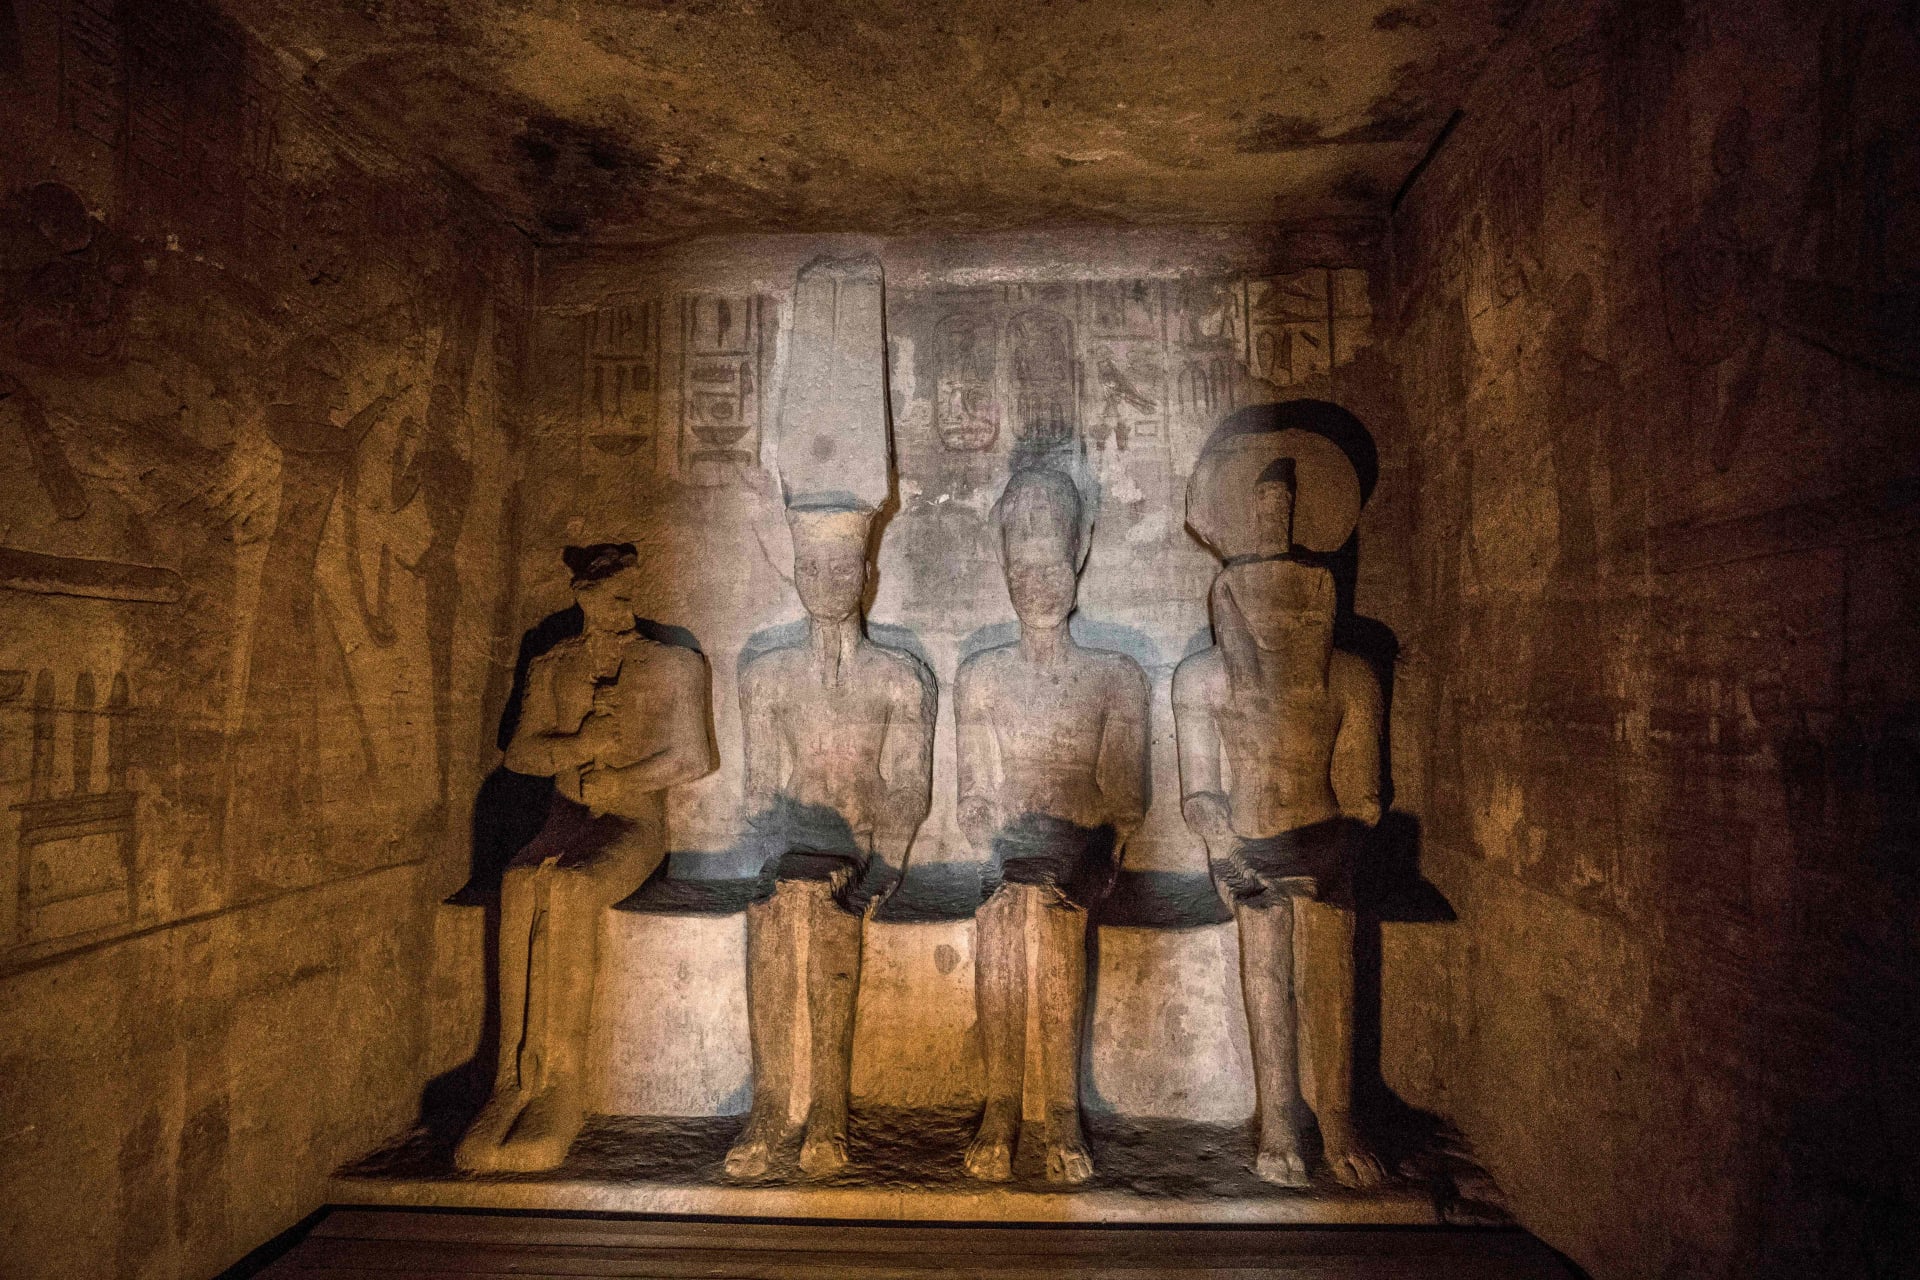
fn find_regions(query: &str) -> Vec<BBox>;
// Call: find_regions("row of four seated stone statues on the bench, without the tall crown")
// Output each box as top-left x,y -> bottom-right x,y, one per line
457,407 -> 1384,1188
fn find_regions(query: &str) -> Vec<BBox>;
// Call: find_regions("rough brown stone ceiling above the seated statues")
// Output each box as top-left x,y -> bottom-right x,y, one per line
225,0 -> 1524,244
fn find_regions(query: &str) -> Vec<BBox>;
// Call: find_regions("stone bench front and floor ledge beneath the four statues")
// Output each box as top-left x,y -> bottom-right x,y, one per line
366,906 -> 1397,1224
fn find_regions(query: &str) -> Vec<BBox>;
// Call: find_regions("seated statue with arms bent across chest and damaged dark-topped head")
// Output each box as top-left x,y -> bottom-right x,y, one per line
455,543 -> 718,1173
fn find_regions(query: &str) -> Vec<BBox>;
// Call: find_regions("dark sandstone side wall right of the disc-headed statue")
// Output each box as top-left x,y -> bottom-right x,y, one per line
1384,2 -> 1920,1278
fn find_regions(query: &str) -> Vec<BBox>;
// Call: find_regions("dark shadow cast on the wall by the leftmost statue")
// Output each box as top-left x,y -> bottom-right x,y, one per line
419,604 -> 701,1157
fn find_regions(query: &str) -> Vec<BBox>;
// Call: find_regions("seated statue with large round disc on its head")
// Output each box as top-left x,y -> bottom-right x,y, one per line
1173,422 -> 1382,1186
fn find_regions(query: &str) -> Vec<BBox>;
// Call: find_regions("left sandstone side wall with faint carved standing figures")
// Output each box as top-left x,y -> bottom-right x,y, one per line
0,0 -> 526,1276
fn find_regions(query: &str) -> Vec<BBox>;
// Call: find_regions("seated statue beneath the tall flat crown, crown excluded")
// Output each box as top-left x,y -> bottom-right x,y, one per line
726,509 -> 937,1178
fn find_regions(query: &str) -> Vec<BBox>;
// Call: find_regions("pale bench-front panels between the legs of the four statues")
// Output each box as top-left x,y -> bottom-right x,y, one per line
560,908 -> 1254,1125
